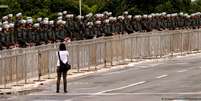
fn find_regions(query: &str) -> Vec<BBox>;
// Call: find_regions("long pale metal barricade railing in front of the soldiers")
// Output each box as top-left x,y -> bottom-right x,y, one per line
0,30 -> 201,88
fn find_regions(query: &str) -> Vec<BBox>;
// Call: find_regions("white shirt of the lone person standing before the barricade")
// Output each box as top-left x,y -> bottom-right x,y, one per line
56,51 -> 69,66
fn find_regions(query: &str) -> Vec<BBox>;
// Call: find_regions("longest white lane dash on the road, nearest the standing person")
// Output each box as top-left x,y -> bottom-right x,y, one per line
95,81 -> 147,95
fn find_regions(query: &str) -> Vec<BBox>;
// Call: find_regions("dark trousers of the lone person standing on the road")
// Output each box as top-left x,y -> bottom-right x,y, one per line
57,67 -> 67,92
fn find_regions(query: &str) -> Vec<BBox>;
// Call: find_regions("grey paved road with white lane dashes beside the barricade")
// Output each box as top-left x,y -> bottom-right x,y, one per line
3,55 -> 201,101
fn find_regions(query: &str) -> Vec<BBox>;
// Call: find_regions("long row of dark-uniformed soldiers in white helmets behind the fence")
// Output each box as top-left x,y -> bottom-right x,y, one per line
0,11 -> 201,49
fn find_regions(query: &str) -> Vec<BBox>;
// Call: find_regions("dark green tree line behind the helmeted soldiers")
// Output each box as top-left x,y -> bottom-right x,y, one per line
0,0 -> 201,18
